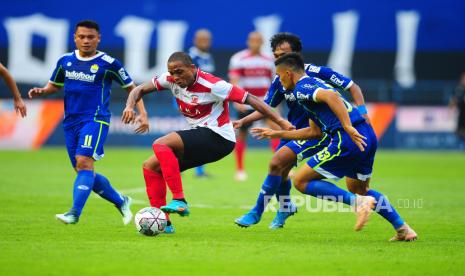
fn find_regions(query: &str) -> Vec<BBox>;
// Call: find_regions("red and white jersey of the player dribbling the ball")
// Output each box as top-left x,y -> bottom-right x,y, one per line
152,69 -> 247,142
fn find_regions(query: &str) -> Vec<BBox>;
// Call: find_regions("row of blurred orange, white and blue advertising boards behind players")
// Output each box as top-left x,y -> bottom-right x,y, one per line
0,100 -> 459,149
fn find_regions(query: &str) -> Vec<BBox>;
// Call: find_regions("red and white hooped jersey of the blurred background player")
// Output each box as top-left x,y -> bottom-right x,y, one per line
229,49 -> 275,98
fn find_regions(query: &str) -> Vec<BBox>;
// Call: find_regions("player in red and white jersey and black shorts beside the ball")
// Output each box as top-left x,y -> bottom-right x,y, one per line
122,52 -> 293,233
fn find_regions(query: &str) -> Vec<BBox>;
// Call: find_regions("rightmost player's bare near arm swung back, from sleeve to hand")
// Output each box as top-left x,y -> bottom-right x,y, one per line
316,89 -> 367,151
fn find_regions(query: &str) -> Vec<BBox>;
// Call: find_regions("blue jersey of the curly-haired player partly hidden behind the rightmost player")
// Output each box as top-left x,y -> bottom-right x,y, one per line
265,64 -> 353,129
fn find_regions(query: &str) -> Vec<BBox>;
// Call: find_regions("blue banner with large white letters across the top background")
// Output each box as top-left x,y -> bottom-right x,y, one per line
0,0 -> 465,88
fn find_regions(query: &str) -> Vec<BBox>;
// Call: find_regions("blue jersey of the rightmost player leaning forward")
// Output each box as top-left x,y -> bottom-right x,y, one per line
293,76 -> 365,133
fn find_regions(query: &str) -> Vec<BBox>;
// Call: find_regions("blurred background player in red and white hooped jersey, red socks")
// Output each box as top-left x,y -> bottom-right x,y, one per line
229,32 -> 279,181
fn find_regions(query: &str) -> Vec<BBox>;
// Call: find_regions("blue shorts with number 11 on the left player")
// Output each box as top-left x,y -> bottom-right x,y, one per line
65,121 -> 109,167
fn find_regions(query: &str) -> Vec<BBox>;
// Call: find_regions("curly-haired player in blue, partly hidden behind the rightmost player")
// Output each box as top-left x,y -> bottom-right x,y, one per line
234,33 -> 368,229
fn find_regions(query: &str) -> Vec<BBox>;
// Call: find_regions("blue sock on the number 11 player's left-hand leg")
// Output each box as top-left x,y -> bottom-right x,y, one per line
72,170 -> 94,217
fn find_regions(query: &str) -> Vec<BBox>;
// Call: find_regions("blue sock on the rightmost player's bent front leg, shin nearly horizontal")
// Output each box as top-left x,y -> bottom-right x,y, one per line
305,180 -> 356,205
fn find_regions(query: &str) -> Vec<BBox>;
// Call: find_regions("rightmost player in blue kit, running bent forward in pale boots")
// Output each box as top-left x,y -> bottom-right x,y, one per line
257,53 -> 417,241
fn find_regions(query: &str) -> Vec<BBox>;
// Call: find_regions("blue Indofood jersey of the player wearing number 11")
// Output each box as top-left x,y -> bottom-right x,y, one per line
50,50 -> 133,128
